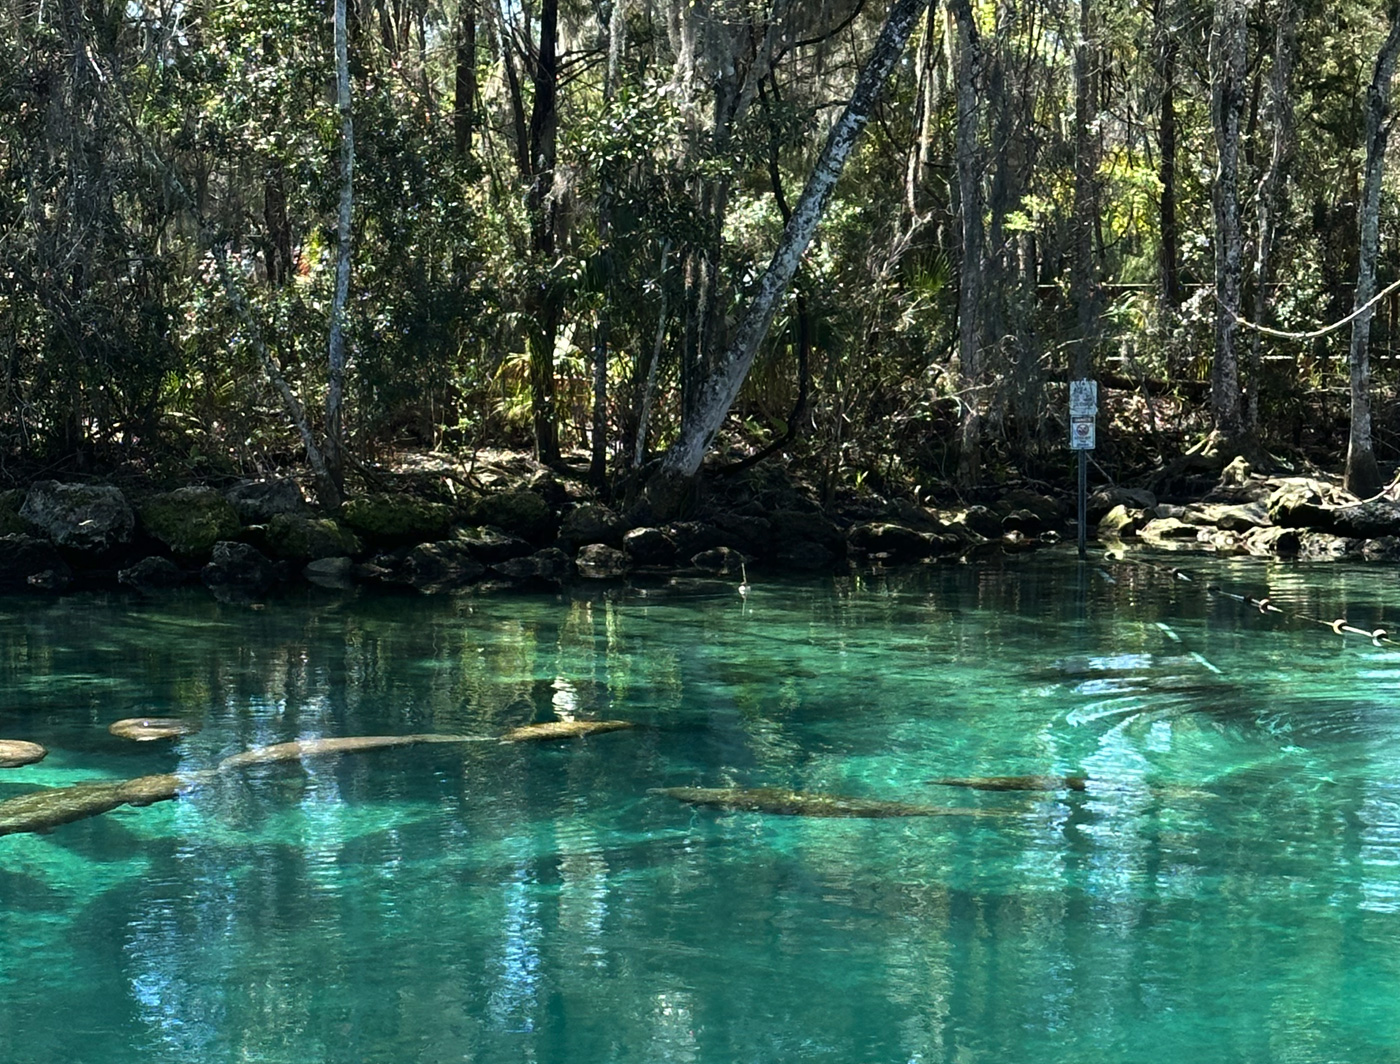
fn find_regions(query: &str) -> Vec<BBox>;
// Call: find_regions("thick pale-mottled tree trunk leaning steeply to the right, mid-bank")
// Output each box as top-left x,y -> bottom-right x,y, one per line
648,0 -> 928,512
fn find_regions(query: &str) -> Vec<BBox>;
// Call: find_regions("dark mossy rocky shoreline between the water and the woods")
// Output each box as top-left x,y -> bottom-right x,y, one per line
0,448 -> 1400,601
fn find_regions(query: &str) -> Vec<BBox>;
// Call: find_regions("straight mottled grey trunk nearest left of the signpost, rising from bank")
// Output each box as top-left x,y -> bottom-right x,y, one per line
951,0 -> 986,483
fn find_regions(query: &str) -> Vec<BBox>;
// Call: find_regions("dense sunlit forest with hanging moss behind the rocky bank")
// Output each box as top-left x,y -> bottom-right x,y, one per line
8,0 -> 1400,508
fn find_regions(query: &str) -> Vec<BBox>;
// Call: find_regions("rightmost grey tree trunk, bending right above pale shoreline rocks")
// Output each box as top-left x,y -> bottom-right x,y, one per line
1344,3 -> 1400,497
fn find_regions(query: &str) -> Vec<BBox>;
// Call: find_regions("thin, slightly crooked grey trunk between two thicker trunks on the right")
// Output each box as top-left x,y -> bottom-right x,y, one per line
1245,0 -> 1298,435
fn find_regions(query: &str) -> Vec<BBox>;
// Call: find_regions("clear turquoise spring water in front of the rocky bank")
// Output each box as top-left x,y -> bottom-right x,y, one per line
0,554 -> 1400,1064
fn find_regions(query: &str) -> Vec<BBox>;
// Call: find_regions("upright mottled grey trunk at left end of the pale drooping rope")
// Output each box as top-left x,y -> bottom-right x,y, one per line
1210,0 -> 1245,449
